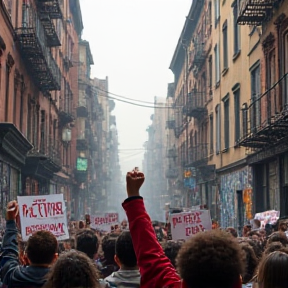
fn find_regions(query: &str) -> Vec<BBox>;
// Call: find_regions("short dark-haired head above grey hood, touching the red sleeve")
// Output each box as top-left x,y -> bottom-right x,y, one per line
114,231 -> 137,269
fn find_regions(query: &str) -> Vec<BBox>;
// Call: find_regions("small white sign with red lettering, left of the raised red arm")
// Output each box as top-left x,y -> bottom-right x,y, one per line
90,212 -> 119,232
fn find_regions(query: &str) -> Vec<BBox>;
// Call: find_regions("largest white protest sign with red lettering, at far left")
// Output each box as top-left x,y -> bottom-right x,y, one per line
17,194 -> 69,241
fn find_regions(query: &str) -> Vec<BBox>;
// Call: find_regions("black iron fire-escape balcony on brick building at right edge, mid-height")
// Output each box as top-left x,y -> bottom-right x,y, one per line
239,74 -> 288,149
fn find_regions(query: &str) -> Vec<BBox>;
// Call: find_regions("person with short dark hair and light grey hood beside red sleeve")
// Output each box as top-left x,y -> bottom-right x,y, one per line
105,231 -> 140,288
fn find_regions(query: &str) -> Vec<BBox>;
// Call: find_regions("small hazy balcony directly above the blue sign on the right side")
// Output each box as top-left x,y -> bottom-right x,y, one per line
188,143 -> 208,167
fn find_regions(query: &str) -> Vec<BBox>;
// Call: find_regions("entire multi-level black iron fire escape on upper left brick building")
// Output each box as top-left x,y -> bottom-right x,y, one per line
15,0 -> 62,92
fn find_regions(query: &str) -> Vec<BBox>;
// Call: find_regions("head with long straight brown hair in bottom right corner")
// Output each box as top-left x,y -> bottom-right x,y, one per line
257,251 -> 288,288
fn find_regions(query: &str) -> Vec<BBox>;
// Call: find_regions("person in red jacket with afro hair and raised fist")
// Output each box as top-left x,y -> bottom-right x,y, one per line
123,171 -> 244,288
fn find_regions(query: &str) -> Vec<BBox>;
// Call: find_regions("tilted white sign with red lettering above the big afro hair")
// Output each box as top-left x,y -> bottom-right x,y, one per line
170,210 -> 212,240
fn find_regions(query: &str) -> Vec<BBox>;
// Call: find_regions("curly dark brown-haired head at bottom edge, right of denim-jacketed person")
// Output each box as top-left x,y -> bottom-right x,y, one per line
43,250 -> 100,288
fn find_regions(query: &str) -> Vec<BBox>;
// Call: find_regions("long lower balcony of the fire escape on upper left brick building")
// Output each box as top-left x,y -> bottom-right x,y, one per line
15,9 -> 61,92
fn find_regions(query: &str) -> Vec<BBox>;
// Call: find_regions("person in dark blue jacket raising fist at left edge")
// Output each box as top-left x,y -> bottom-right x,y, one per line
0,201 -> 58,288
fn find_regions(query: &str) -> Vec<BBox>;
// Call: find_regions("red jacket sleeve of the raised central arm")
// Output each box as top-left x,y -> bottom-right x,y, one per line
123,199 -> 181,288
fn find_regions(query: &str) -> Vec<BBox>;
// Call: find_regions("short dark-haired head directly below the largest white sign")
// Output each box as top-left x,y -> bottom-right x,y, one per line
26,231 -> 58,266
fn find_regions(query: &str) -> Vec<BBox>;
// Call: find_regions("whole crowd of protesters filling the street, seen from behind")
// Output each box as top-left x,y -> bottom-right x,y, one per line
0,171 -> 288,288
